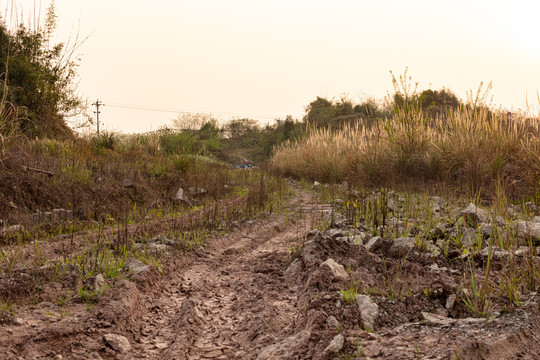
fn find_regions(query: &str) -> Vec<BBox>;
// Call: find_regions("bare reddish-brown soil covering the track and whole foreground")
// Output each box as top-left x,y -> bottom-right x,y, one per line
0,189 -> 540,360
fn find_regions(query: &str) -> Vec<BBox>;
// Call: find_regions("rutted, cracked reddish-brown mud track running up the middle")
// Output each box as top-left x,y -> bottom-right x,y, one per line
134,190 -> 324,359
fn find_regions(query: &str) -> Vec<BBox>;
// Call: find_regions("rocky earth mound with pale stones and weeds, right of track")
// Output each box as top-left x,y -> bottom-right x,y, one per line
278,194 -> 540,359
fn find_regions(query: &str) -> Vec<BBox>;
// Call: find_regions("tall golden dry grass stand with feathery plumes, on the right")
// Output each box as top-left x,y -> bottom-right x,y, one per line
270,97 -> 540,197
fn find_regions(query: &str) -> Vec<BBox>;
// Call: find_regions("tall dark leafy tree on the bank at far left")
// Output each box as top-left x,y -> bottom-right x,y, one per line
0,2 -> 82,136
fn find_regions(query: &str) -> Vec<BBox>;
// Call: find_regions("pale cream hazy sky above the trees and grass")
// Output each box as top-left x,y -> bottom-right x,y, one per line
4,0 -> 540,132
